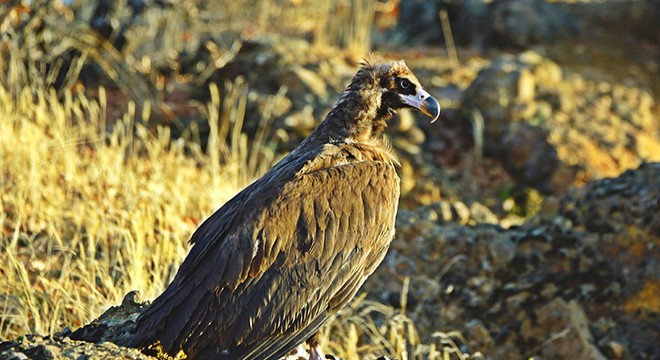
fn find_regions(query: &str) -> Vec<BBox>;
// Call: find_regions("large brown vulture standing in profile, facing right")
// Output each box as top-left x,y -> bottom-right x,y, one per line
129,60 -> 440,359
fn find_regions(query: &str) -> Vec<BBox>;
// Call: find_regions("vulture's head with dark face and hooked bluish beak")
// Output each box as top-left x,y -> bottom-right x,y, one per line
363,61 -> 440,122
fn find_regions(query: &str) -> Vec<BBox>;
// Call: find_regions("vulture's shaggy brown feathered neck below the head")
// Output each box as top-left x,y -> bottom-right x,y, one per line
310,78 -> 391,142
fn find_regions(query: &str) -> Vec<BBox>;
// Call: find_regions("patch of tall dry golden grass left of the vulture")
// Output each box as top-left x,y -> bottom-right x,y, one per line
0,82 -> 245,338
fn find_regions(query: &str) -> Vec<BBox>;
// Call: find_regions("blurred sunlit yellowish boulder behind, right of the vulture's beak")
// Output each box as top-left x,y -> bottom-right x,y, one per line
461,51 -> 660,194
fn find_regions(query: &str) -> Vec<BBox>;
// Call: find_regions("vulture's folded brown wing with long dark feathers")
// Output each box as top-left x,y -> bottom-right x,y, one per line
129,148 -> 399,359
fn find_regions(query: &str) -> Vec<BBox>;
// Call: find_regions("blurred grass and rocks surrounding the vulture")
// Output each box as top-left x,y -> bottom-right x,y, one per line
0,0 -> 660,359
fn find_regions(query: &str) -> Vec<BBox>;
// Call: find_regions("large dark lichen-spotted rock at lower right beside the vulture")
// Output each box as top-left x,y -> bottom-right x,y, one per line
366,163 -> 660,359
